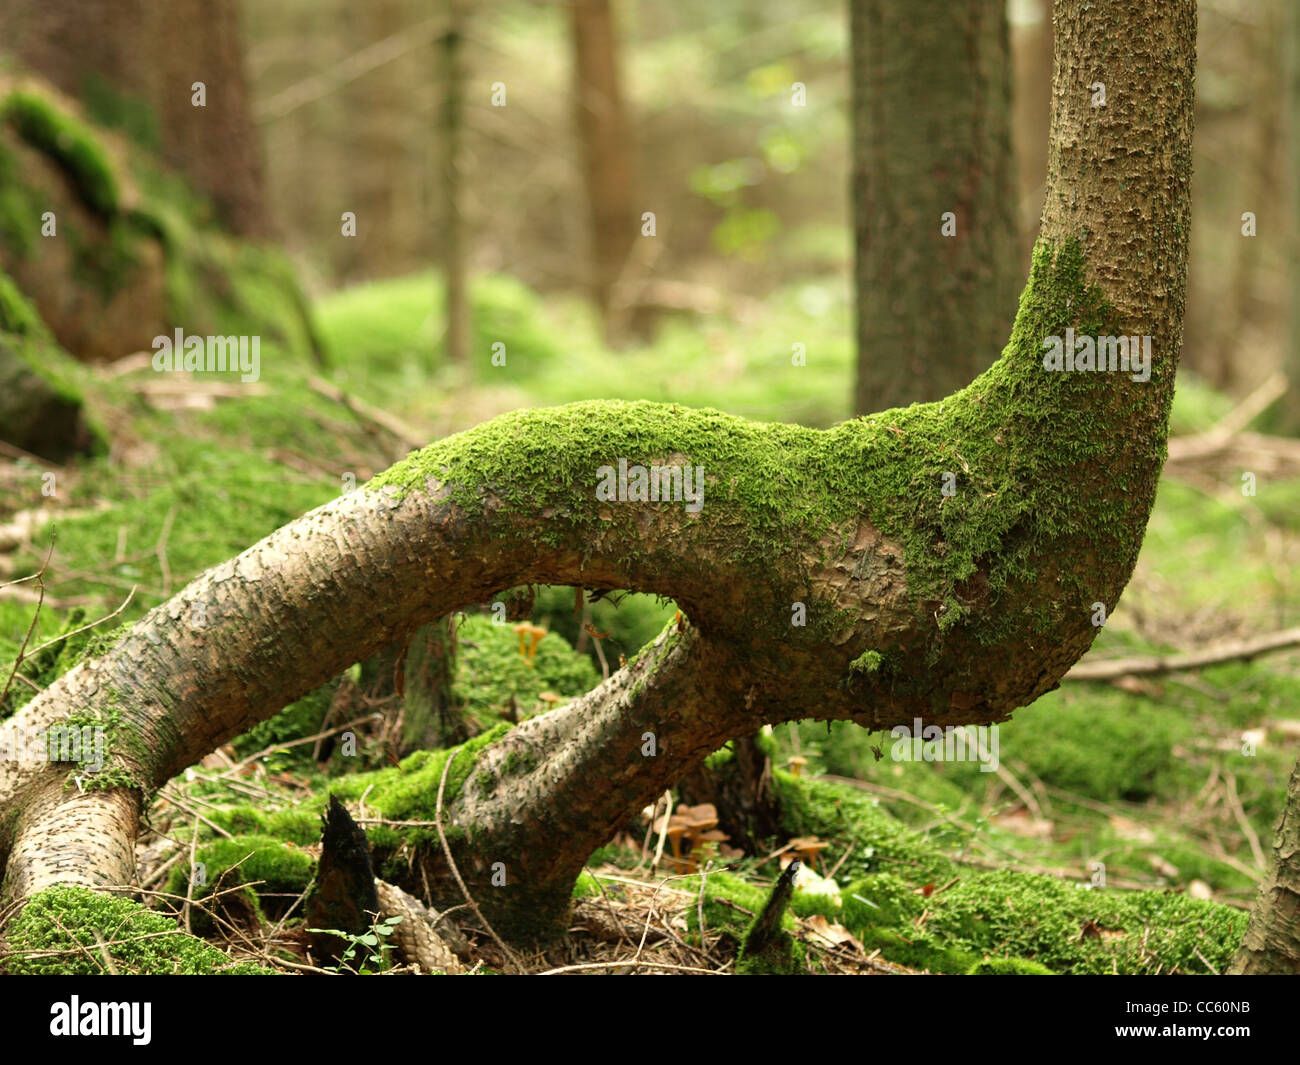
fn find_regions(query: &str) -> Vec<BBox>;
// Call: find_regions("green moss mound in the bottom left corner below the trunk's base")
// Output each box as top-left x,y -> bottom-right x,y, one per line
3,887 -> 270,977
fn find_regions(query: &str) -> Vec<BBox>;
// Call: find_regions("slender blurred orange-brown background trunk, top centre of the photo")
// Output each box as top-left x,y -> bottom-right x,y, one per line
569,0 -> 637,345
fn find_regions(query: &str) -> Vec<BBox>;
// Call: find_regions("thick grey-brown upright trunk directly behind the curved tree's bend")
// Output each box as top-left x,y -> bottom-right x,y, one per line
849,0 -> 1021,414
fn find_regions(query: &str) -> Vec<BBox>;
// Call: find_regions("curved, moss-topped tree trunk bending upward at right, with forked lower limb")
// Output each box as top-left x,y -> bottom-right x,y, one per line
0,0 -> 1196,936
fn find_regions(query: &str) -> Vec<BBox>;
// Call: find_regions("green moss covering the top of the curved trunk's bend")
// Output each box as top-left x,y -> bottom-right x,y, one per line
369,241 -> 1149,665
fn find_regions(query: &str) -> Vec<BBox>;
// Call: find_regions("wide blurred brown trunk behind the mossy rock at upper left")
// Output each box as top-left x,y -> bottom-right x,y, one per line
0,0 -> 269,237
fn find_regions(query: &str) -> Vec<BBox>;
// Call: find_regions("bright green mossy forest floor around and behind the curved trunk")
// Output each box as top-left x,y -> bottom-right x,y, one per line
0,110 -> 1300,974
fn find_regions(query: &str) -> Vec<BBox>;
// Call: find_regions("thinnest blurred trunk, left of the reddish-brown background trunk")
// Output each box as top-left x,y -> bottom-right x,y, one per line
439,0 -> 469,363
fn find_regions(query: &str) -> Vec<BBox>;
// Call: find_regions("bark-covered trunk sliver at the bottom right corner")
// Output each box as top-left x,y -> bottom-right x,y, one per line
1229,762 -> 1300,977
